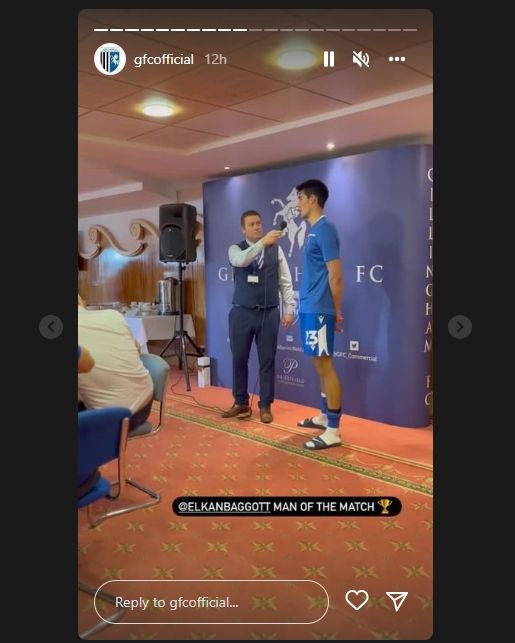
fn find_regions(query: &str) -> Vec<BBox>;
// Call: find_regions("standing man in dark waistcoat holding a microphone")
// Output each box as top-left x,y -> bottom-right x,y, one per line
222,210 -> 295,424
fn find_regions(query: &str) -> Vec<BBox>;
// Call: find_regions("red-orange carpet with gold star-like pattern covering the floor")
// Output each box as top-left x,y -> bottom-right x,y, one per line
78,372 -> 432,640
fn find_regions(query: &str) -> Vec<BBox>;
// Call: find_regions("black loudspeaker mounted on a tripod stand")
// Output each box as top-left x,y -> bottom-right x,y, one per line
159,203 -> 197,262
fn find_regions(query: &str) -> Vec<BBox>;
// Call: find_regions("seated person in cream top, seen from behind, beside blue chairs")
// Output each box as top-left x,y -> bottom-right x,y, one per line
78,297 -> 154,430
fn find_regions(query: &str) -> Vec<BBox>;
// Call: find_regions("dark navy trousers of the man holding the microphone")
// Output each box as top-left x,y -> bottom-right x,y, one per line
229,306 -> 280,408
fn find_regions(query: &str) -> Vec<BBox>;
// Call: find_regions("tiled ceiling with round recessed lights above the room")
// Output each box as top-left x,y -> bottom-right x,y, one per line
78,9 -> 433,216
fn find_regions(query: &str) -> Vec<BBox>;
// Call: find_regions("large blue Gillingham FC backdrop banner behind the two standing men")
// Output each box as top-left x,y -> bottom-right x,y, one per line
203,145 -> 433,427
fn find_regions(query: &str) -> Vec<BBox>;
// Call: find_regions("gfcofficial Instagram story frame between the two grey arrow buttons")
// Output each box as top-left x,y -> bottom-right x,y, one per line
77,9 -> 436,640
